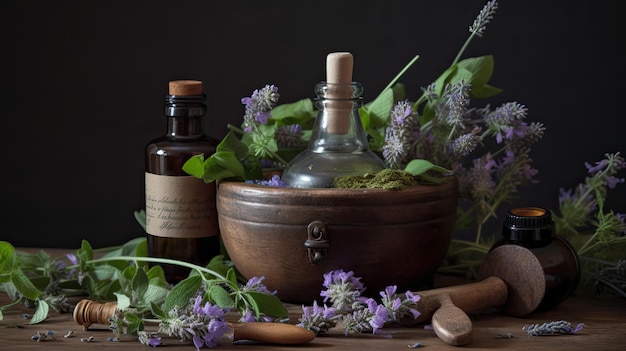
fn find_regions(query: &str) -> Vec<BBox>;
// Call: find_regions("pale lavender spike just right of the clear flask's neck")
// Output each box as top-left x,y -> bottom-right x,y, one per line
382,100 -> 417,168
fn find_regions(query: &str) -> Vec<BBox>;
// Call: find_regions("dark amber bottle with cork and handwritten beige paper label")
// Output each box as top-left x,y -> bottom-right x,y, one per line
145,80 -> 220,283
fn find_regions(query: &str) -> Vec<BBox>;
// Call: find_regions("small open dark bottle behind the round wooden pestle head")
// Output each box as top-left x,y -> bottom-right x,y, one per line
491,207 -> 580,311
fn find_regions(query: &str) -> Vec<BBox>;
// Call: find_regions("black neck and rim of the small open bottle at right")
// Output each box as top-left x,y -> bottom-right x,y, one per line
502,207 -> 554,242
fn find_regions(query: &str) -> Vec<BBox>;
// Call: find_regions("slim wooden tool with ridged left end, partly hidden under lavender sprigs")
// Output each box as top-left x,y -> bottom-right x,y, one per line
73,299 -> 315,345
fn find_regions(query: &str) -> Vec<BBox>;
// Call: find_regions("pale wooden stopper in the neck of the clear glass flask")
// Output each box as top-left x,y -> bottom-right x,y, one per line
326,52 -> 354,134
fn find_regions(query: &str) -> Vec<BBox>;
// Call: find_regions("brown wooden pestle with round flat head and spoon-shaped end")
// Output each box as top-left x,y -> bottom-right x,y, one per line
416,245 -> 546,346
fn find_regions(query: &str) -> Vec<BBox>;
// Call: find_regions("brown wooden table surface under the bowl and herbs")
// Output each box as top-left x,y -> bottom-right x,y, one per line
0,249 -> 626,351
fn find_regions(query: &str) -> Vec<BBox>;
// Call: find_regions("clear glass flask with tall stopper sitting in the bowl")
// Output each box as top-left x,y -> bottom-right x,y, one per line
282,53 -> 385,188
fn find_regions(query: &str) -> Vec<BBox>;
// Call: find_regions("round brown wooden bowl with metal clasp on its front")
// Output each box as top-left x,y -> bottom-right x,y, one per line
217,177 -> 458,303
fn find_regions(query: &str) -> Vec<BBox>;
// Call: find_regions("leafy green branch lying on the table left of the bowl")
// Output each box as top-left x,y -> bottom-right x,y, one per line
0,238 -> 287,329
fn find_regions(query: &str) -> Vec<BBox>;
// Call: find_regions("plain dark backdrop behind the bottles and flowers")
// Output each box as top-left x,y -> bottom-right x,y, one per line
0,0 -> 626,248
